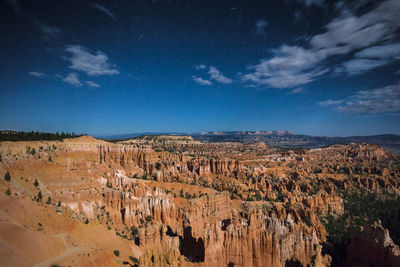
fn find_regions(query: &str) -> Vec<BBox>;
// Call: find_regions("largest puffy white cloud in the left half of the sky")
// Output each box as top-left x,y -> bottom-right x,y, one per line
65,45 -> 119,76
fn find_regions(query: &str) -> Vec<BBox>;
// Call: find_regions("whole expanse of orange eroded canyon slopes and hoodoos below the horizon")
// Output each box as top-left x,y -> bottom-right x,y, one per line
0,136 -> 400,266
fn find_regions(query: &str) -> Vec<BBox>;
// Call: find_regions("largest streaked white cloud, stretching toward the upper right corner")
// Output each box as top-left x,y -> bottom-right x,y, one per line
241,0 -> 400,88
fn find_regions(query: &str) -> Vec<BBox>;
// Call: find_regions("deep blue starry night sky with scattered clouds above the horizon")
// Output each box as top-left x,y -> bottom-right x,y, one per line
0,0 -> 400,136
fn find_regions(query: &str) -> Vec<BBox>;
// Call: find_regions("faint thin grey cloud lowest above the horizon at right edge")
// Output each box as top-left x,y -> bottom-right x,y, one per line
318,82 -> 400,114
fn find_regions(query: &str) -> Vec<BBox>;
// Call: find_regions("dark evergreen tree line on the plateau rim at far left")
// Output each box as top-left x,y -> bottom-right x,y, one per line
0,131 -> 83,141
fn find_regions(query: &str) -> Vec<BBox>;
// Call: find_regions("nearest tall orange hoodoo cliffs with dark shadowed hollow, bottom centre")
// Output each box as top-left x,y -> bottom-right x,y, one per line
101,174 -> 328,266
